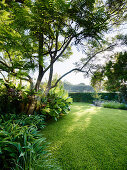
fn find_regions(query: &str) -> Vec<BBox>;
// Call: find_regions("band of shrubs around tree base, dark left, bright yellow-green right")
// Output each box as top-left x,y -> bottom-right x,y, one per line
0,80 -> 72,119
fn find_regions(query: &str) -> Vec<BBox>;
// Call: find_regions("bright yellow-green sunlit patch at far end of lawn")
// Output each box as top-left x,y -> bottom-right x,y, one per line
44,103 -> 101,130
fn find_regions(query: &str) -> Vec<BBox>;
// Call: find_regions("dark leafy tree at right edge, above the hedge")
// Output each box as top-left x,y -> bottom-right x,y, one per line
92,52 -> 127,101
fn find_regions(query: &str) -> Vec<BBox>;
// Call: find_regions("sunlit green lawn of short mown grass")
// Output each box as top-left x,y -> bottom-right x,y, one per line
43,103 -> 127,170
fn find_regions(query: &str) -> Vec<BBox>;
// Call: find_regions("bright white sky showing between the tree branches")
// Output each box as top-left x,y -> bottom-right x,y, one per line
46,24 -> 127,85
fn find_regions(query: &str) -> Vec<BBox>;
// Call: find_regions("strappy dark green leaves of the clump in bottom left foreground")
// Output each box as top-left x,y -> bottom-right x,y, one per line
0,114 -> 60,170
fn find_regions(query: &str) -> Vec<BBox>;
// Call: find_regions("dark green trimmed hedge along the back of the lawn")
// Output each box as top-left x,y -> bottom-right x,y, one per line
69,93 -> 119,103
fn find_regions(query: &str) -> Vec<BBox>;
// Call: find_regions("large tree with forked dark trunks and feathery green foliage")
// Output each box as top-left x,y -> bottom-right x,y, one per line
2,0 -> 116,91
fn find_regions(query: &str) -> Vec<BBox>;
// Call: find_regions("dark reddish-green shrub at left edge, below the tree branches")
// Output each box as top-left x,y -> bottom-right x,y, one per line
0,83 -> 29,114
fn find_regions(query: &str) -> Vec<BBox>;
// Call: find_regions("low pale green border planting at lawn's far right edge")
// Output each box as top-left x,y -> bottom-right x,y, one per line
102,101 -> 127,110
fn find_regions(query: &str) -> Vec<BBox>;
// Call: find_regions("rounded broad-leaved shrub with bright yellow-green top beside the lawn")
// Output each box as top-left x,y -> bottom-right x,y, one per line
39,86 -> 72,120
